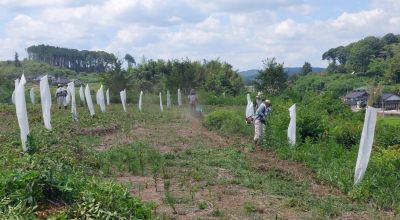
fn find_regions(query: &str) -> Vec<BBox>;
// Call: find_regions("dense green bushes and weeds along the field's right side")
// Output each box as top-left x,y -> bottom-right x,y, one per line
205,90 -> 400,212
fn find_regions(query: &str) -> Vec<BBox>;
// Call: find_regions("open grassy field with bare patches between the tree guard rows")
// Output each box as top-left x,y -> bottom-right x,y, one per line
0,97 -> 394,219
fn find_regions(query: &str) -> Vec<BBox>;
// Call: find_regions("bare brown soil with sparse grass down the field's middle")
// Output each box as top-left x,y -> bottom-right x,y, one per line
97,113 -> 391,219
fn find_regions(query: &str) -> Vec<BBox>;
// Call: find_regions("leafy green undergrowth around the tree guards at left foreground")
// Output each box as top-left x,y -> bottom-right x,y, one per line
0,105 -> 159,219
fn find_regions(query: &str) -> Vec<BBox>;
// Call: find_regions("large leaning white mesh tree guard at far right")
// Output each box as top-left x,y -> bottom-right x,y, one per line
354,106 -> 377,185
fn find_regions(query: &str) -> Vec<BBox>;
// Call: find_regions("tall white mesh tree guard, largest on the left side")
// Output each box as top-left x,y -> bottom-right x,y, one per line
15,74 -> 29,151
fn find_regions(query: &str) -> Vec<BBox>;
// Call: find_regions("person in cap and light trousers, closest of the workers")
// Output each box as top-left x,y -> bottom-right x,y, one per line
254,100 -> 271,145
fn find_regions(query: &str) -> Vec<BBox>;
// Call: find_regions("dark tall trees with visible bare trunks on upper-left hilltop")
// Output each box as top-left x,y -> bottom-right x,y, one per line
26,44 -> 117,72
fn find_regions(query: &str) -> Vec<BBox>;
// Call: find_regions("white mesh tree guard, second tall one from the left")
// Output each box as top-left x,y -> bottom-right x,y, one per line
40,75 -> 51,130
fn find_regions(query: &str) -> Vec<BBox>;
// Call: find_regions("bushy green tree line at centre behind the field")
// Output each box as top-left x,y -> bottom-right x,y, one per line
102,58 -> 245,101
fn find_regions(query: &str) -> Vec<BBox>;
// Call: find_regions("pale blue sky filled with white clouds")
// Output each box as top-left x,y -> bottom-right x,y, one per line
0,0 -> 400,70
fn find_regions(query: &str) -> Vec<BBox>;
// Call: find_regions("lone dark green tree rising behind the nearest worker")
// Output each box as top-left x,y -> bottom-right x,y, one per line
254,58 -> 288,95
